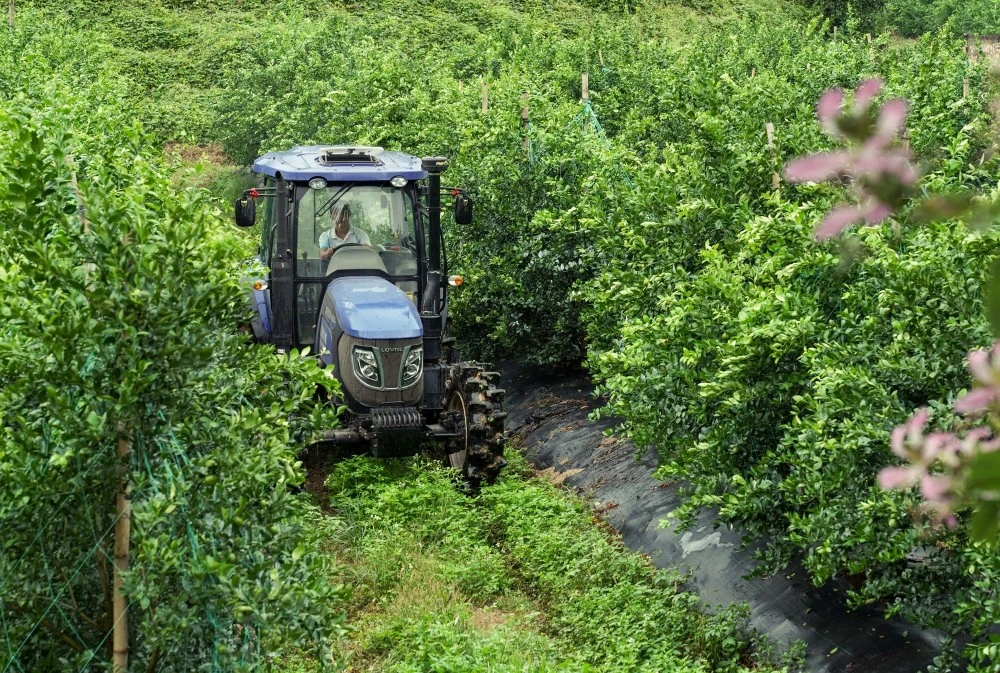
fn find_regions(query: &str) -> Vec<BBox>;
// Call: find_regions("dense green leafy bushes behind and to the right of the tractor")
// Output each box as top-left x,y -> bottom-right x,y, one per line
211,9 -> 998,665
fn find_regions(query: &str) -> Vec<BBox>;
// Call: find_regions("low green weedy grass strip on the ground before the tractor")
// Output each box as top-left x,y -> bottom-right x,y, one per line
280,456 -> 796,673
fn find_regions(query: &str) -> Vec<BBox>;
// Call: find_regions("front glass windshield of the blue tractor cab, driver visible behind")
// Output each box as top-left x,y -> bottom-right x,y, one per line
295,183 -> 422,343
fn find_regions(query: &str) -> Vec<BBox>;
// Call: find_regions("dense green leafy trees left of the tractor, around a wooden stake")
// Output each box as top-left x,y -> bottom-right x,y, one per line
0,81 -> 341,671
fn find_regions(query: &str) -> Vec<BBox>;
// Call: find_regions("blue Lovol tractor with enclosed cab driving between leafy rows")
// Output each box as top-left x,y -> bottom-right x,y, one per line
236,146 -> 506,483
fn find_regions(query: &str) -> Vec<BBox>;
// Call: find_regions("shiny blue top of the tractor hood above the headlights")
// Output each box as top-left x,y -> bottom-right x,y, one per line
326,276 -> 423,339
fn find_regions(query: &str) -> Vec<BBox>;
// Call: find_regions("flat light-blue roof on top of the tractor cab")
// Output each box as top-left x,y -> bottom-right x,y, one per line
253,145 -> 427,182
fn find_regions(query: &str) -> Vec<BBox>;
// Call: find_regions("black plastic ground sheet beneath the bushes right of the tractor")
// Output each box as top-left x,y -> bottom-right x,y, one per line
500,362 -> 941,673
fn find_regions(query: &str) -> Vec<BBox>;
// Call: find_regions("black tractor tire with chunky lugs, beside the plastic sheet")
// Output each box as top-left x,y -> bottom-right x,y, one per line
446,362 -> 507,486
